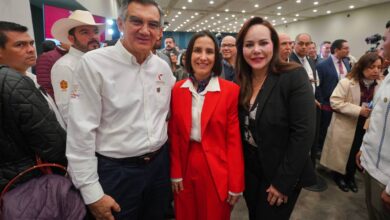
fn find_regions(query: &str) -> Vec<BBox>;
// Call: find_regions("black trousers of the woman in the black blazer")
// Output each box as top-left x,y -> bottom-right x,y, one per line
244,146 -> 301,220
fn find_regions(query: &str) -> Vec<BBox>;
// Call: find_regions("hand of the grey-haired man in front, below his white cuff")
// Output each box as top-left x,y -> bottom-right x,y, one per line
88,195 -> 121,220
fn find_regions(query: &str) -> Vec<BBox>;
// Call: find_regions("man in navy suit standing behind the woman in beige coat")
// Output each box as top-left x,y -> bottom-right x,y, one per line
317,39 -> 351,182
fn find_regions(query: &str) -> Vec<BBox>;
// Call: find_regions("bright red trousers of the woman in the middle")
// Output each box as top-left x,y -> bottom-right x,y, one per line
174,141 -> 232,220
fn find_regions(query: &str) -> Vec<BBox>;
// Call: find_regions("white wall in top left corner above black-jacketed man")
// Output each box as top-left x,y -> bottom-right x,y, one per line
0,0 -> 34,39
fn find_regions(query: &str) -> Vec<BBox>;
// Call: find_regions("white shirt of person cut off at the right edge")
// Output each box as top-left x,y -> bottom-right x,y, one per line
360,75 -> 390,195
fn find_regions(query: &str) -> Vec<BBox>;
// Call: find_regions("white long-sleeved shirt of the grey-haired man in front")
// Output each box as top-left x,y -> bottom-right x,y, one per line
66,41 -> 176,204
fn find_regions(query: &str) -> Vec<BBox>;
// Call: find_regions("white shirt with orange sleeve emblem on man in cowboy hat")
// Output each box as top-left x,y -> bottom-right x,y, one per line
51,47 -> 84,123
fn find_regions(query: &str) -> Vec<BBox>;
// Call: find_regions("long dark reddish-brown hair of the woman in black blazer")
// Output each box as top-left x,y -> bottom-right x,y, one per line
236,17 -> 300,110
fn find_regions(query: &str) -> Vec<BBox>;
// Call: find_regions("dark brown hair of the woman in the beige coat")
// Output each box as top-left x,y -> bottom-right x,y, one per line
347,52 -> 383,82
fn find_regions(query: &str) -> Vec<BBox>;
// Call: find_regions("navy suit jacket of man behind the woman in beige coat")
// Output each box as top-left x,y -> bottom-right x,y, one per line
317,56 -> 351,105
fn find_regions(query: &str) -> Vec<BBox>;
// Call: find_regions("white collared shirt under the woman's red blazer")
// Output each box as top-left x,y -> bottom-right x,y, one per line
181,77 -> 221,142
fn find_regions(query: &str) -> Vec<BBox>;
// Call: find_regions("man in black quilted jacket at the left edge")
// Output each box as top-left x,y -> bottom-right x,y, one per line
0,21 -> 67,191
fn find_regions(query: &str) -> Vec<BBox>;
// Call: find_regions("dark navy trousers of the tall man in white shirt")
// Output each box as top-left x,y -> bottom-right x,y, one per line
98,145 -> 170,220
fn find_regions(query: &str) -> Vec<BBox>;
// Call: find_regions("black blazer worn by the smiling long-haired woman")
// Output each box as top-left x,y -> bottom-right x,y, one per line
239,67 -> 316,195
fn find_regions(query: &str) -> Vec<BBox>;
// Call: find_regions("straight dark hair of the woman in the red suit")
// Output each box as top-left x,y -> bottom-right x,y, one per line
185,30 -> 222,76
